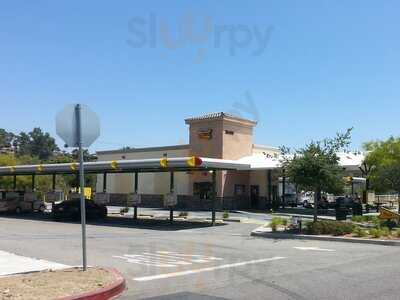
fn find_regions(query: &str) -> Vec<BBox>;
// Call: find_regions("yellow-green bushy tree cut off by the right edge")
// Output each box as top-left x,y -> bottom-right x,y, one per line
364,137 -> 400,213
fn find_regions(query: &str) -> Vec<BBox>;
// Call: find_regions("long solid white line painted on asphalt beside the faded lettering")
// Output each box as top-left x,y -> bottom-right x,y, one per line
133,256 -> 286,282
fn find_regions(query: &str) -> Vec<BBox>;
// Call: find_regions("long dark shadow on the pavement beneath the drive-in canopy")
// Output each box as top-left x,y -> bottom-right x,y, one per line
0,213 -> 226,231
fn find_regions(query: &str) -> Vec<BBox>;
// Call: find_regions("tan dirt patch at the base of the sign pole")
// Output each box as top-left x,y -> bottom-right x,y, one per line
0,268 -> 115,300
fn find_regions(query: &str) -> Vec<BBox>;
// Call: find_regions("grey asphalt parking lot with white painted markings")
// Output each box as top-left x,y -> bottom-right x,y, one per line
0,216 -> 400,299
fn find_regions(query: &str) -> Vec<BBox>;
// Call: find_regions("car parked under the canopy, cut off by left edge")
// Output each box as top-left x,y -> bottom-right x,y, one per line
0,191 -> 46,214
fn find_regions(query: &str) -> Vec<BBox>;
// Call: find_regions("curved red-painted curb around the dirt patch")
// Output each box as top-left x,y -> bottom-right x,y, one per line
59,268 -> 126,300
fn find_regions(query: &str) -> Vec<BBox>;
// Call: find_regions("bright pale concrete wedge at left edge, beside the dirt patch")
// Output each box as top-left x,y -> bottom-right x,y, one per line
0,251 -> 70,277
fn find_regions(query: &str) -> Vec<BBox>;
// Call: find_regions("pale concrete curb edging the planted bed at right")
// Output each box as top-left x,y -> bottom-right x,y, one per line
251,229 -> 400,247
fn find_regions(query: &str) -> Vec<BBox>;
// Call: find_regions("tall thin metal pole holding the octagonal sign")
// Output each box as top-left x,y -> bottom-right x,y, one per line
75,104 -> 87,271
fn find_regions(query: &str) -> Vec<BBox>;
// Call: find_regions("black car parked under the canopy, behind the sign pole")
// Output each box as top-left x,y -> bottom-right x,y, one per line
52,199 -> 107,220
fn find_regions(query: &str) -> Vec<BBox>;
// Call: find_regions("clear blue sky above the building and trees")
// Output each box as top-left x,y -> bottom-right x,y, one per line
0,0 -> 400,150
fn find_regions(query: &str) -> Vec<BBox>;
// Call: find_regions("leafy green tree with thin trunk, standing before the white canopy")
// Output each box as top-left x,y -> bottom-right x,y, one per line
282,129 -> 352,222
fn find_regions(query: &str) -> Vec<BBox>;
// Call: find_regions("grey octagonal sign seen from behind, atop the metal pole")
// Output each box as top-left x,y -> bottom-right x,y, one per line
56,104 -> 100,147
